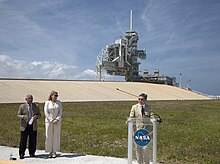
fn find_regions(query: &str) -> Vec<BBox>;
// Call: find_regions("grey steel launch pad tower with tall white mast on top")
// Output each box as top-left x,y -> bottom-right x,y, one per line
96,10 -> 177,86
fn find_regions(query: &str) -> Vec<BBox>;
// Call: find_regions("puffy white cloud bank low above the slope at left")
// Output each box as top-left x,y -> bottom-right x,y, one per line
0,55 -> 96,80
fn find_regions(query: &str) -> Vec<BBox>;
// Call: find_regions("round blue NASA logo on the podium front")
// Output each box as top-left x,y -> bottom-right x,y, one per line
134,129 -> 151,147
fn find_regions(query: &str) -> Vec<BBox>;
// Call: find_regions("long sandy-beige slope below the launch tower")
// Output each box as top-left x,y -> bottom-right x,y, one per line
0,79 -> 209,103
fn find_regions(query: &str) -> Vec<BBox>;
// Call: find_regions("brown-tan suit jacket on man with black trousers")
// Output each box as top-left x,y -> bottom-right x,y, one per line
18,103 -> 41,131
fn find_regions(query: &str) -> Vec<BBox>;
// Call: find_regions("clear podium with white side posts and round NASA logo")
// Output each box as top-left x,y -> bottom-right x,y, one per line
127,115 -> 161,164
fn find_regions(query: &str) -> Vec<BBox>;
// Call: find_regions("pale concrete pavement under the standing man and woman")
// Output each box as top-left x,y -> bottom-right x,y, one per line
0,146 -> 131,164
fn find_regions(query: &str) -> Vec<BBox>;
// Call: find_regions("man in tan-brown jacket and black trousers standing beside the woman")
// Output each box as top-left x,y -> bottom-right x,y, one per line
18,94 -> 41,159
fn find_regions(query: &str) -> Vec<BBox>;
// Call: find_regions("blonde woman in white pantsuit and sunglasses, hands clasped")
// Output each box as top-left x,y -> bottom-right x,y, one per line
44,91 -> 62,158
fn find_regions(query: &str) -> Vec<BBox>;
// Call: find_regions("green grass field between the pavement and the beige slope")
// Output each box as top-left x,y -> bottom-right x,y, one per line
0,100 -> 220,164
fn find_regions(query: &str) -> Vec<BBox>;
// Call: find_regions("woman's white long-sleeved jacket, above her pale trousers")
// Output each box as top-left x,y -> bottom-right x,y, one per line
44,100 -> 62,122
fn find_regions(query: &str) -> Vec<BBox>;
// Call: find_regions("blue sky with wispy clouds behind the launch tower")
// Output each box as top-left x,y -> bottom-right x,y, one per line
0,0 -> 220,95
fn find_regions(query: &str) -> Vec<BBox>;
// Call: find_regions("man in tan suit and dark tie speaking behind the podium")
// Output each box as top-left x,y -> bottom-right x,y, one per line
129,93 -> 153,164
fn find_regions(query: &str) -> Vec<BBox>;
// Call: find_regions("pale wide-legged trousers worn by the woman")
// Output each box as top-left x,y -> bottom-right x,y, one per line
45,121 -> 61,153
